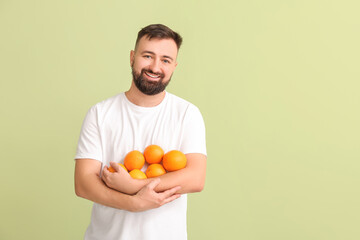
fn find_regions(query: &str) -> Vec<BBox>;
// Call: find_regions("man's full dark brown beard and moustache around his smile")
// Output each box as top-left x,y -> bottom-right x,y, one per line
131,67 -> 171,95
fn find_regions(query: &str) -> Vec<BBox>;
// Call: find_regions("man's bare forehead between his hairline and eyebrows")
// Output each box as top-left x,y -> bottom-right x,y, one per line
136,36 -> 178,59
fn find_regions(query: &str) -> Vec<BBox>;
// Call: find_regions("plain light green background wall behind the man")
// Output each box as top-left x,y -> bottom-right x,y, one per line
0,0 -> 360,240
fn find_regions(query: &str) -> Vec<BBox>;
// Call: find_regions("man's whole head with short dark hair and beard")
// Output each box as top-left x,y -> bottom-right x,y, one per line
130,24 -> 182,95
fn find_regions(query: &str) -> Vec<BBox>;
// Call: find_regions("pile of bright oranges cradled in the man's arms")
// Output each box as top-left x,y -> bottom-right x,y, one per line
108,145 -> 187,179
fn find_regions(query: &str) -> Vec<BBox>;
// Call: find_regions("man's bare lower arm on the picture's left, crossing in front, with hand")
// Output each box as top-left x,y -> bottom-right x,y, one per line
75,159 -> 180,212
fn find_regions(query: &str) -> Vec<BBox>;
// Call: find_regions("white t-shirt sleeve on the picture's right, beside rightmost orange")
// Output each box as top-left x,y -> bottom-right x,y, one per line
180,105 -> 207,155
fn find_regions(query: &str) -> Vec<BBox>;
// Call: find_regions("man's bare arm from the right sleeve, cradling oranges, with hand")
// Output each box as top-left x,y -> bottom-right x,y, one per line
103,153 -> 206,194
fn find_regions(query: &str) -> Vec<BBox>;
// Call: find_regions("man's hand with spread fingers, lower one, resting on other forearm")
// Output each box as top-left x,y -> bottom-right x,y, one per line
133,178 -> 181,212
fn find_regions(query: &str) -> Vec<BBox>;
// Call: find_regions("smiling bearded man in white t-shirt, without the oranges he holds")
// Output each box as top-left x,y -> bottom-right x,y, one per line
75,24 -> 206,240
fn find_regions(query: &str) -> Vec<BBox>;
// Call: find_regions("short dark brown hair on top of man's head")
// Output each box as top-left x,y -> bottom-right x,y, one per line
135,24 -> 182,50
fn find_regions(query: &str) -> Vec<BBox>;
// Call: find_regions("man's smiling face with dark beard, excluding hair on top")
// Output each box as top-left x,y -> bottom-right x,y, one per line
130,36 -> 178,95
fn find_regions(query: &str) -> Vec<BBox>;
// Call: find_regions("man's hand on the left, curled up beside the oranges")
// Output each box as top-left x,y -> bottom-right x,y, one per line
101,162 -> 137,194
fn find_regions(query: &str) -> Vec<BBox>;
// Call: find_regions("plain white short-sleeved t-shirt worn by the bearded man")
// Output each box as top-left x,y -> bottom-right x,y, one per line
75,92 -> 206,240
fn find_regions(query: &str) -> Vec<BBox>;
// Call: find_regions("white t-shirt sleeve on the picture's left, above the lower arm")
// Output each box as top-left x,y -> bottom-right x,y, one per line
75,106 -> 102,162
